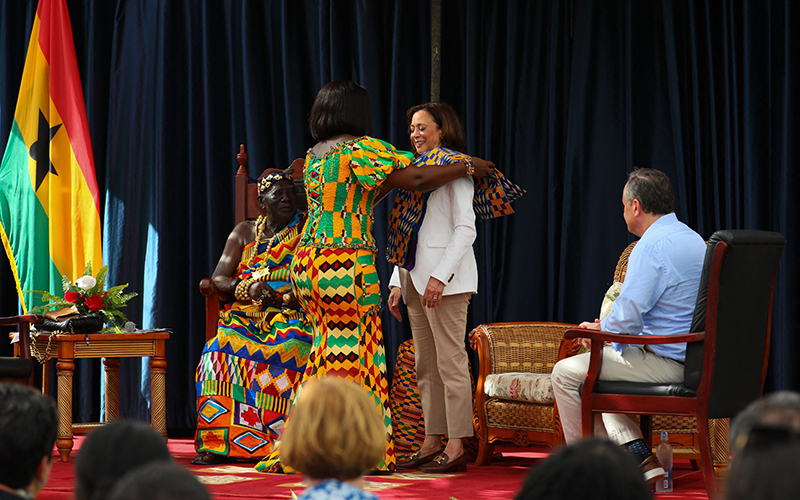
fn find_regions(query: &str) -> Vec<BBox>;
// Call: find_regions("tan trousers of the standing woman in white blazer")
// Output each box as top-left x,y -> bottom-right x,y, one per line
404,286 -> 473,438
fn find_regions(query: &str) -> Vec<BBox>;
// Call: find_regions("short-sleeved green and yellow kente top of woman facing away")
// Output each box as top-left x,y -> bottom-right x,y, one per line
300,136 -> 412,251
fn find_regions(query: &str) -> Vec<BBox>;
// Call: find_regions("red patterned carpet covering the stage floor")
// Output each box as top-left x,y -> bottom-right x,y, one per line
38,437 -> 708,500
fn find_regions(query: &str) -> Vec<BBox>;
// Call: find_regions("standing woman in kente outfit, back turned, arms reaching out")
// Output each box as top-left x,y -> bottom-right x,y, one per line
256,80 -> 493,472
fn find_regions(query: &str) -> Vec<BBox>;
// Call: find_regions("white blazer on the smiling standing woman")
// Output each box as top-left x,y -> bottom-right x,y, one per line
389,176 -> 478,301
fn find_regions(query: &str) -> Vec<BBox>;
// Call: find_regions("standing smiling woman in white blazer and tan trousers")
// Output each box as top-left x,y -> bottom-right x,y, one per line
388,102 -> 478,473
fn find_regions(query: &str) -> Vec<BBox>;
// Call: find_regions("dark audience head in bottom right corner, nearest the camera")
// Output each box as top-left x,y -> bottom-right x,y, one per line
725,424 -> 800,500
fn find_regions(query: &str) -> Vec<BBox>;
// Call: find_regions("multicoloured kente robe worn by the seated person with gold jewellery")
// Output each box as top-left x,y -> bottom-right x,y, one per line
195,216 -> 312,458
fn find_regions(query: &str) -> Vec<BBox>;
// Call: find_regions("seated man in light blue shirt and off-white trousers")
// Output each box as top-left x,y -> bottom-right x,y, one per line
552,168 -> 706,482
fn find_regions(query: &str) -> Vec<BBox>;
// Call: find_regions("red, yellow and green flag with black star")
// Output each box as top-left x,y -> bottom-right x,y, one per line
0,0 -> 103,311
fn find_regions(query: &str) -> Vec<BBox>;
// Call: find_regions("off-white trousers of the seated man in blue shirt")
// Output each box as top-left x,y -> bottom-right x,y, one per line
552,346 -> 683,444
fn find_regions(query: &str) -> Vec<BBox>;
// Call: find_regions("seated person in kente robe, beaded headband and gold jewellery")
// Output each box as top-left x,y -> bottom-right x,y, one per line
192,169 -> 311,465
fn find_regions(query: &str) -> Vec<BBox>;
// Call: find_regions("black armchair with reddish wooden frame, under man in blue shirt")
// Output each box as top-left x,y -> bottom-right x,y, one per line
564,230 -> 786,500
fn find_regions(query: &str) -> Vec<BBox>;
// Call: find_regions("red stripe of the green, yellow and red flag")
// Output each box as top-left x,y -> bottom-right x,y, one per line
36,0 -> 100,213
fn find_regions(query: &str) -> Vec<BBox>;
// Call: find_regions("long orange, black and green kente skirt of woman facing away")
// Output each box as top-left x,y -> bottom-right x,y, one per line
256,247 -> 395,472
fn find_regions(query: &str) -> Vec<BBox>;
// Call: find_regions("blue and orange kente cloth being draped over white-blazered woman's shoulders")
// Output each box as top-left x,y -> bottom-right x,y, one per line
386,148 -> 525,271
